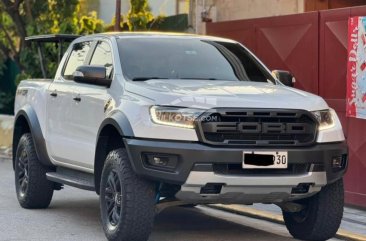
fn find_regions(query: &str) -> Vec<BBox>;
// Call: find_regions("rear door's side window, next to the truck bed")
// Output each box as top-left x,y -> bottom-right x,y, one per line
63,42 -> 90,80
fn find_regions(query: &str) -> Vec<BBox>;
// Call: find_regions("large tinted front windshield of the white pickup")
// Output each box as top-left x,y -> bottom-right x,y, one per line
118,37 -> 274,82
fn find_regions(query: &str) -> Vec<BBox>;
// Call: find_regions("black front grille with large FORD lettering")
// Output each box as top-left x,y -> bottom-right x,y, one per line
196,108 -> 317,147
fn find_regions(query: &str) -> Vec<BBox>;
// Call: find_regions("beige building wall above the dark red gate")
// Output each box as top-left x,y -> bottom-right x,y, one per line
194,0 -> 366,34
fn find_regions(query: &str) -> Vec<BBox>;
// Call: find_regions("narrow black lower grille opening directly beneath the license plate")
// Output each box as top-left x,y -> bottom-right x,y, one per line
213,163 -> 310,176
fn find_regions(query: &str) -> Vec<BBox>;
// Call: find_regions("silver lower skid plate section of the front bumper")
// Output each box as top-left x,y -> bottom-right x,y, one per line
175,171 -> 327,204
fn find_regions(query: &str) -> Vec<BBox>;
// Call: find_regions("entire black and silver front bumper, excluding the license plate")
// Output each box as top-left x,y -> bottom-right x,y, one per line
124,139 -> 348,204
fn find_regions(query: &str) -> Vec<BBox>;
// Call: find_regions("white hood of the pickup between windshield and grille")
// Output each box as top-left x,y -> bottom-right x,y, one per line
125,79 -> 329,111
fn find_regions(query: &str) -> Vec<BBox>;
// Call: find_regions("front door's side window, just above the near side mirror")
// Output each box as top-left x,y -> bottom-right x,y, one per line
90,41 -> 113,79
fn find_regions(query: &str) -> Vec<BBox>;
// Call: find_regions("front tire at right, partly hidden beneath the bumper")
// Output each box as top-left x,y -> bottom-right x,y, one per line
283,179 -> 344,240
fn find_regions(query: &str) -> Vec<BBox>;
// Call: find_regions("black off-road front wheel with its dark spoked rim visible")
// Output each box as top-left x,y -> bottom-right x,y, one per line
100,148 -> 155,241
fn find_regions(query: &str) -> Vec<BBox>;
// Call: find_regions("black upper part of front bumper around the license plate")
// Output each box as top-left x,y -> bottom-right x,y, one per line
124,139 -> 348,185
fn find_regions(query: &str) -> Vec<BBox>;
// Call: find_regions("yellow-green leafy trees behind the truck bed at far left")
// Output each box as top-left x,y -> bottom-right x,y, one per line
0,0 -> 104,77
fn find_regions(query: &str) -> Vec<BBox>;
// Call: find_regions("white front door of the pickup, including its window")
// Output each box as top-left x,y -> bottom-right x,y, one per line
69,40 -> 113,169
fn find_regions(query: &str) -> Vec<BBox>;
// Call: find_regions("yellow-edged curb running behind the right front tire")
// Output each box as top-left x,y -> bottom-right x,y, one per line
206,204 -> 366,241
